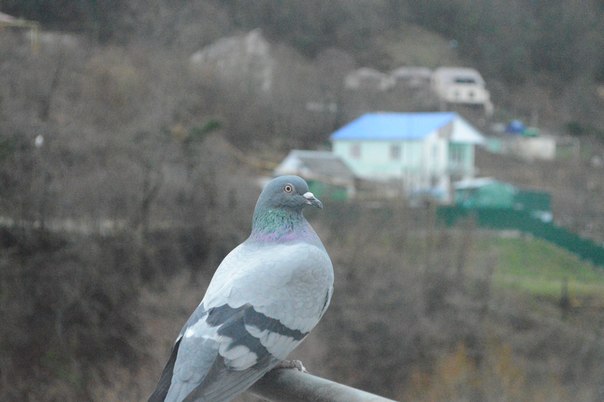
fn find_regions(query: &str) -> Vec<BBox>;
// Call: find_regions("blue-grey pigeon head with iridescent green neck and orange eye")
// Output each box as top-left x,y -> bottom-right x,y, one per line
252,176 -> 323,239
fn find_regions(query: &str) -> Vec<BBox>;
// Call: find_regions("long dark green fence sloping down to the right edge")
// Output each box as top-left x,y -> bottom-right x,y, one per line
437,207 -> 604,267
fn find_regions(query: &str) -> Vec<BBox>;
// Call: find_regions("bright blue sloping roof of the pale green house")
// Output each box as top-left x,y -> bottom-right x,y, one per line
330,112 -> 459,141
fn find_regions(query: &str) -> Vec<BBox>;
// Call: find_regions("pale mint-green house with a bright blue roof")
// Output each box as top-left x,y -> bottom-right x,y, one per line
330,112 -> 484,200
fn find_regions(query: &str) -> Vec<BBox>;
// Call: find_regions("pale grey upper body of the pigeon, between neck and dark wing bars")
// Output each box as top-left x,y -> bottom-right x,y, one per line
204,242 -> 333,340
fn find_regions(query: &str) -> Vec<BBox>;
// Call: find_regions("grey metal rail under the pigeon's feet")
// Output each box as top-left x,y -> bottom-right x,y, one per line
249,369 -> 395,402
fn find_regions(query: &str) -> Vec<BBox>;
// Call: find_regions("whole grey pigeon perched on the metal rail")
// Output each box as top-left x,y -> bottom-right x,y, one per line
149,176 -> 334,402
